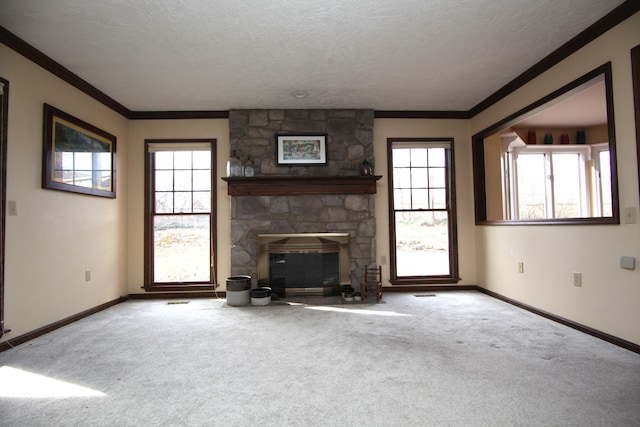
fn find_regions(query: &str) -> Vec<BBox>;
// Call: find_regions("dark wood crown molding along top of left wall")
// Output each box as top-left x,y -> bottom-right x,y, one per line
0,26 -> 131,118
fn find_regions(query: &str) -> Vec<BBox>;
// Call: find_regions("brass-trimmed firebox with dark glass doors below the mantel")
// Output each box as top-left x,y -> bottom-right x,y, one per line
258,233 -> 351,296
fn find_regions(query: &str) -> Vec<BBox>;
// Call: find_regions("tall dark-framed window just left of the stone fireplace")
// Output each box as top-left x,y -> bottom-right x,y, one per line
145,140 -> 216,291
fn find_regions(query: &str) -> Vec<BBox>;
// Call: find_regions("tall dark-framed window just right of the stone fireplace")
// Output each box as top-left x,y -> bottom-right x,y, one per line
388,138 -> 459,284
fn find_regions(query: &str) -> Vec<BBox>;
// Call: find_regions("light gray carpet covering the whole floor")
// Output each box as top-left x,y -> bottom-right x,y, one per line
0,292 -> 640,426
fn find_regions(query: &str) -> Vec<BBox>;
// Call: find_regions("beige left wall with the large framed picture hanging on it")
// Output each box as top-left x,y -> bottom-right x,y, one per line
0,44 -> 129,340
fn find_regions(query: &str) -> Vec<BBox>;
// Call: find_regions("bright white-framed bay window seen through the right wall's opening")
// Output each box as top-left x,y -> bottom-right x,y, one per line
504,144 -> 612,220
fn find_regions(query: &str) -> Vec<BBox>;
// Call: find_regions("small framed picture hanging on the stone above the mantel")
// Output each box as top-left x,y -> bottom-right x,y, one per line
276,134 -> 328,166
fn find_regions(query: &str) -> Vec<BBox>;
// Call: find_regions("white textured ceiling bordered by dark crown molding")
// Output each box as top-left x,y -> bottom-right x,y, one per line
0,0 -> 624,111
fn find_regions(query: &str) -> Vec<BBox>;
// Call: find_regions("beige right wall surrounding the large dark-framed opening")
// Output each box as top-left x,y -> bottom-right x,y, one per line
470,14 -> 640,344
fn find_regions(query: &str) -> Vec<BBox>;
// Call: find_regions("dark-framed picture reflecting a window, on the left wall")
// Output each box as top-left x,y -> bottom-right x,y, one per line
42,104 -> 116,199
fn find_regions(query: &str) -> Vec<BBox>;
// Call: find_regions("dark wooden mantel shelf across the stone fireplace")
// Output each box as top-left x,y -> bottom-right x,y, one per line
222,175 -> 382,196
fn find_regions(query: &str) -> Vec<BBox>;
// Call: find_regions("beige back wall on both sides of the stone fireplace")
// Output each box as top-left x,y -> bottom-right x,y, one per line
128,119 -> 475,294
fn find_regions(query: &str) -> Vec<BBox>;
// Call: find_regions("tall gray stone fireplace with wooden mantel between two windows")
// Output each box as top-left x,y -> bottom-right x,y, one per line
224,110 -> 379,294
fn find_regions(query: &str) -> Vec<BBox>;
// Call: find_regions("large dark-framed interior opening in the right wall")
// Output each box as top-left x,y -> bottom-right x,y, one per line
472,62 -> 620,225
